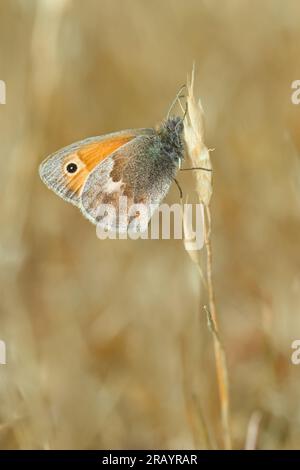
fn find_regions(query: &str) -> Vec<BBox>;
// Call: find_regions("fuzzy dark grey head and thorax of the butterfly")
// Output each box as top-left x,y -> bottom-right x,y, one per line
158,116 -> 184,161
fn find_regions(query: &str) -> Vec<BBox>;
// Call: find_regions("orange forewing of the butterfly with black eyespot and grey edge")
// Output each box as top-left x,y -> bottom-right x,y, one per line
39,129 -> 153,207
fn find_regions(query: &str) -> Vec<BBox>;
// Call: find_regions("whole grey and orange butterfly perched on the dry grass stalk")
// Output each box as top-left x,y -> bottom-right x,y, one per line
40,117 -> 183,232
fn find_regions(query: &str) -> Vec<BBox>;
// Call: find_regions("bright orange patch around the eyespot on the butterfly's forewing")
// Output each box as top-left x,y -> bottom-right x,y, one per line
63,135 -> 135,194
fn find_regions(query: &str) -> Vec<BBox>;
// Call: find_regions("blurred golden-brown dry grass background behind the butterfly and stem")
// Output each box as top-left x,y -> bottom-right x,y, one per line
0,0 -> 300,449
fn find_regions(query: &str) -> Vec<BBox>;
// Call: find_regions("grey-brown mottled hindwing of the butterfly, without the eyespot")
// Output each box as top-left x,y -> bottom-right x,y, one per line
81,133 -> 177,233
